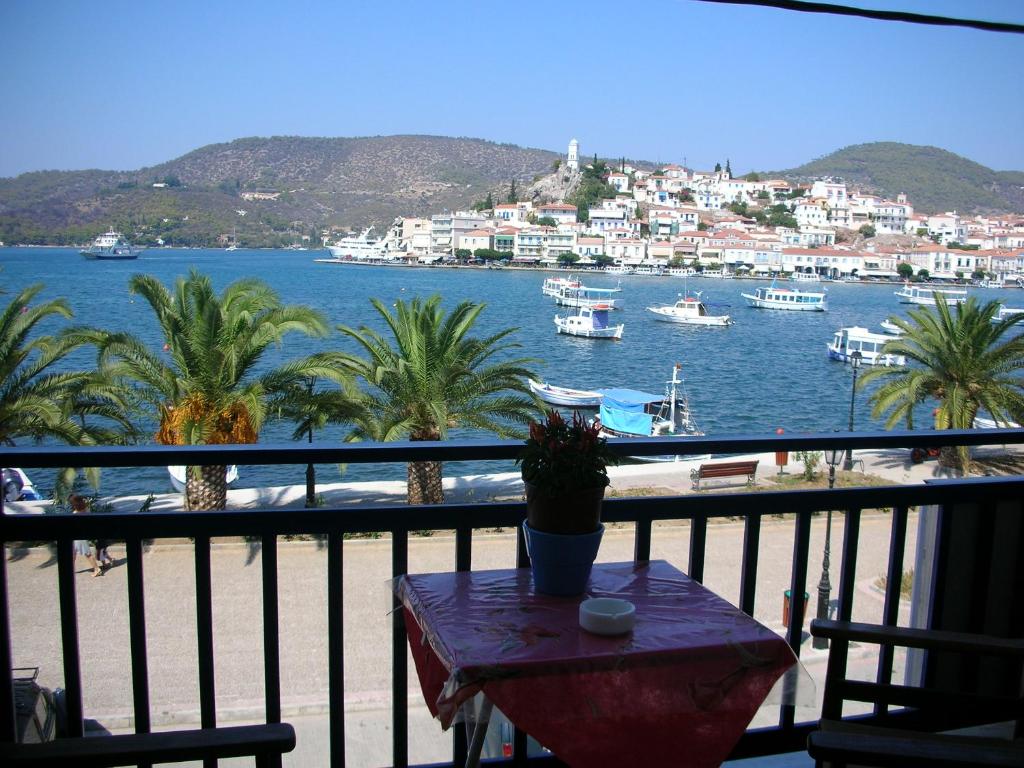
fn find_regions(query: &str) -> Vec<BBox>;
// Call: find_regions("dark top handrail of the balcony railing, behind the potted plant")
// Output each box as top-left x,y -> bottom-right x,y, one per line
0,428 -> 1024,467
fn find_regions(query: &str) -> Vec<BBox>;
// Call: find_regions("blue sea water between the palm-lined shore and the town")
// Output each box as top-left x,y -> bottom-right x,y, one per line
0,248 -> 1024,494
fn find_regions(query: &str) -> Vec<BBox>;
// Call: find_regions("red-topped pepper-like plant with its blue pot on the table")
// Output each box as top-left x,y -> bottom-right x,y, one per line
516,411 -> 617,595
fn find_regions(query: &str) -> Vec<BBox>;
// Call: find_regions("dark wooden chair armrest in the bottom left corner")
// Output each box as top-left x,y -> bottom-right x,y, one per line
0,723 -> 295,768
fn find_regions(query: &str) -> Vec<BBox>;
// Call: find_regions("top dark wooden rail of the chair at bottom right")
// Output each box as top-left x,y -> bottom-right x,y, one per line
811,618 -> 1024,657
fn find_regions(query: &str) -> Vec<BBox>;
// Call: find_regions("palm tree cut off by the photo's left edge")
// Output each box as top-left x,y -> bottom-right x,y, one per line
0,285 -> 131,445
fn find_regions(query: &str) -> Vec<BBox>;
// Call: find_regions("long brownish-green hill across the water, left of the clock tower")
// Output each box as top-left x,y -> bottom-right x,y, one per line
0,136 -> 559,246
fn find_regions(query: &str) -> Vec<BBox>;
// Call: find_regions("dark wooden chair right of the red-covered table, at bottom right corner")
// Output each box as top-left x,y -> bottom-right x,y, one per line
807,620 -> 1024,768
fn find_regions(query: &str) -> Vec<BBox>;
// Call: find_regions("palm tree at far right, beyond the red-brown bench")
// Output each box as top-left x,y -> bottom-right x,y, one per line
859,294 -> 1024,472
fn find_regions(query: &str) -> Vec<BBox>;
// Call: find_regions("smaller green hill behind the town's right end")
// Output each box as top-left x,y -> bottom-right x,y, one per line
778,141 -> 1024,213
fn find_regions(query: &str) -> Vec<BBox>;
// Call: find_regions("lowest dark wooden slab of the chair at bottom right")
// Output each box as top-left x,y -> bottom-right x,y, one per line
807,731 -> 1024,768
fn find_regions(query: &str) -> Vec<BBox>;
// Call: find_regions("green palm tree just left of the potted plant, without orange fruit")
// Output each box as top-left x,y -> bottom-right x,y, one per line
330,296 -> 540,504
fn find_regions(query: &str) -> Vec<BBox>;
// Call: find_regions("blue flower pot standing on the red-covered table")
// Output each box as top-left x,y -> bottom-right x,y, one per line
522,520 -> 604,597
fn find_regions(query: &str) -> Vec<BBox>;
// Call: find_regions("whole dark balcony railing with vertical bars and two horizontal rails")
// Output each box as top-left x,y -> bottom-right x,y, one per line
0,430 -> 1024,767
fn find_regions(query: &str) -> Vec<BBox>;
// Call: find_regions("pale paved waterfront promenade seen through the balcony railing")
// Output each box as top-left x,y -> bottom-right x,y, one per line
8,451 -> 1015,766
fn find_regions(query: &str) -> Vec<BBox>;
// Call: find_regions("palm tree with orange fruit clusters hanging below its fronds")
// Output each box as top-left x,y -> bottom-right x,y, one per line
100,270 -> 327,509
